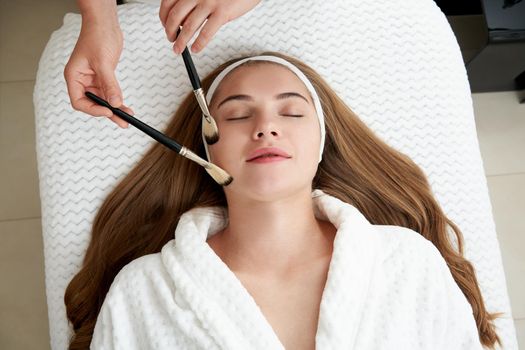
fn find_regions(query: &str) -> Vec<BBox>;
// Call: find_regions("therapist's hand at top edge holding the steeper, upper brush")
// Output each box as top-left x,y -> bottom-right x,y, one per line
159,0 -> 261,53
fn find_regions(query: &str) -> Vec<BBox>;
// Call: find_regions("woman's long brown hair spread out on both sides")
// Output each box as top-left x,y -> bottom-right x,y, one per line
64,52 -> 501,349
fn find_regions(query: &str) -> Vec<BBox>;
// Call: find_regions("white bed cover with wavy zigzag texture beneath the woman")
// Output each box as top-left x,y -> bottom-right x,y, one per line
34,0 -> 517,350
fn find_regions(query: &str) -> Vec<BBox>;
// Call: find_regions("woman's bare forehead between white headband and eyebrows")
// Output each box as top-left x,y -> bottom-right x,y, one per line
212,62 -> 309,103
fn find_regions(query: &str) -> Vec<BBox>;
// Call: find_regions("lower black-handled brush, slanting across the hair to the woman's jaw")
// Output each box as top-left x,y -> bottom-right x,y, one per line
86,91 -> 233,186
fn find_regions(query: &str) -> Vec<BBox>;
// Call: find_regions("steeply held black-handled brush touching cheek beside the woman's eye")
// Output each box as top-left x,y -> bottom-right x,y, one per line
175,26 -> 219,145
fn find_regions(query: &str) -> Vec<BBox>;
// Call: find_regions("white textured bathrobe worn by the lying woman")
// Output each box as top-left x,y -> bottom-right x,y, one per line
91,190 -> 482,350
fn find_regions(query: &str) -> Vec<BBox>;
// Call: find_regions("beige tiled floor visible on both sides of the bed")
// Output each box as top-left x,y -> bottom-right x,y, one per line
0,0 -> 525,350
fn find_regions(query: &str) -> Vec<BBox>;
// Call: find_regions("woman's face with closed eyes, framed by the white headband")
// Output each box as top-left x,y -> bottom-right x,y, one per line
208,63 -> 321,201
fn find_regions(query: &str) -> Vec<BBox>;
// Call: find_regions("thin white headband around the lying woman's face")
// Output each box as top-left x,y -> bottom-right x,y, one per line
202,56 -> 325,163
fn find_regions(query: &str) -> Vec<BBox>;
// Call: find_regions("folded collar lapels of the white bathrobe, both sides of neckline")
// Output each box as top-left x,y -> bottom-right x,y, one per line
161,190 -> 380,350
